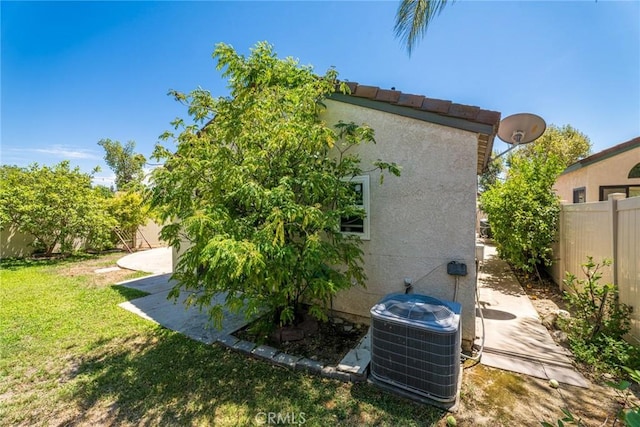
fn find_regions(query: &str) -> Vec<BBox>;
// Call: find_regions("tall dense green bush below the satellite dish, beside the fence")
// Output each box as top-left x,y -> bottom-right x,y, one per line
480,145 -> 563,271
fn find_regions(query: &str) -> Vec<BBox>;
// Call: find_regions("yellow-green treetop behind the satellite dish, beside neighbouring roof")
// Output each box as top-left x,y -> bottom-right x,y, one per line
512,125 -> 591,168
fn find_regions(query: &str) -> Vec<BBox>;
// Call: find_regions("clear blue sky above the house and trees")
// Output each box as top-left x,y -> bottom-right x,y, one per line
0,0 -> 640,184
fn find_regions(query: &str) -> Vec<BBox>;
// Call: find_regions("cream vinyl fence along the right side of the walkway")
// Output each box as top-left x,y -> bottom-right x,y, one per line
551,193 -> 640,344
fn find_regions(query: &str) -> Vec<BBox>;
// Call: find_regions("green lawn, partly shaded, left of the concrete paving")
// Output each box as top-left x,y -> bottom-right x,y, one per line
0,255 -> 445,426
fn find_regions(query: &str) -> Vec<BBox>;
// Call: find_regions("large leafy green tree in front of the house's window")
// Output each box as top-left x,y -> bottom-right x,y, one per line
151,42 -> 399,324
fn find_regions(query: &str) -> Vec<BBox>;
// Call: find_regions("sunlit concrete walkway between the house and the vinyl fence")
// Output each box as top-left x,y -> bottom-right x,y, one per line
476,245 -> 589,387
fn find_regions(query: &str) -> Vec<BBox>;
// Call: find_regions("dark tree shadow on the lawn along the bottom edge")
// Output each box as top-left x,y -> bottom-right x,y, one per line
64,328 -> 442,425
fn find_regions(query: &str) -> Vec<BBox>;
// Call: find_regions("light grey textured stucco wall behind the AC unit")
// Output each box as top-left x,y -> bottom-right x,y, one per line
322,101 -> 477,347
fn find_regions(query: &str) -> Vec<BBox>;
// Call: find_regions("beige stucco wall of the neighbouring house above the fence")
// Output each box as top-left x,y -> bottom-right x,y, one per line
554,147 -> 640,203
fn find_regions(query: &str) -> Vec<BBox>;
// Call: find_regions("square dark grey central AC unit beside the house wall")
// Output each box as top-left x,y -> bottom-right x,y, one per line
371,294 -> 461,403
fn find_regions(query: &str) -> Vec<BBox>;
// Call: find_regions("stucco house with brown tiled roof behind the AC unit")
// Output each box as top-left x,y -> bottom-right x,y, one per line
173,82 -> 500,349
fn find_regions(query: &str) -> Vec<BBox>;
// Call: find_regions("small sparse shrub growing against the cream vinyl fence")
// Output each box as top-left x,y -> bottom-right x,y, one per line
563,257 -> 640,372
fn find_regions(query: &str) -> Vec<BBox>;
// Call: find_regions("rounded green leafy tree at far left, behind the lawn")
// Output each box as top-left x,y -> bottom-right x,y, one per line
0,161 -> 114,255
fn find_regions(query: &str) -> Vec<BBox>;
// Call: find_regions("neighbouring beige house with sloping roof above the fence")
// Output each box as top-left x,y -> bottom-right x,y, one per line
554,137 -> 640,203
